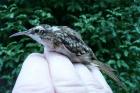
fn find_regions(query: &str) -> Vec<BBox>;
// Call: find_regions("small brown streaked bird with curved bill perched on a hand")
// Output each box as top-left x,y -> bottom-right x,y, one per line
10,24 -> 126,90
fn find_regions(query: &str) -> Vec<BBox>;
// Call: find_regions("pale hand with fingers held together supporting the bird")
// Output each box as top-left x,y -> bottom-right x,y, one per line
12,53 -> 112,93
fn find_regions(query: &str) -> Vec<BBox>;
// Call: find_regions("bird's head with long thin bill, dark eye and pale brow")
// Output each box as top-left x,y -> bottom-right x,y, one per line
10,24 -> 51,43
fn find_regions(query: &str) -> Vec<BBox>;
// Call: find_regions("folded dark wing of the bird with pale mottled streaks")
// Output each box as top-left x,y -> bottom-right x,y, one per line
56,31 -> 89,56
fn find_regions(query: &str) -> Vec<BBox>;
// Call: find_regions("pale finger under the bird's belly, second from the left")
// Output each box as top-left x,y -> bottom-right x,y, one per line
44,53 -> 87,93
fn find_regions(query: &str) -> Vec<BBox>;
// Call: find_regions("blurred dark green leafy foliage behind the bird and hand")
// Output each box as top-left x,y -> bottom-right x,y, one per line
0,0 -> 140,93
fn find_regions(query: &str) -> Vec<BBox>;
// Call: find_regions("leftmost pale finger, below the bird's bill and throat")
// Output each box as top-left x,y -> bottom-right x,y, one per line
12,53 -> 54,93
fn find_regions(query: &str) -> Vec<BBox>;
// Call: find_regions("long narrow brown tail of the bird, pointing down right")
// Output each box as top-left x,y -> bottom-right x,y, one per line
93,60 -> 127,91
